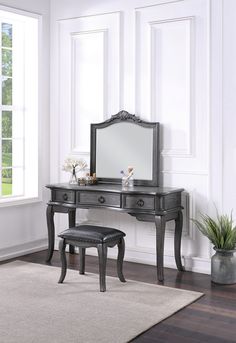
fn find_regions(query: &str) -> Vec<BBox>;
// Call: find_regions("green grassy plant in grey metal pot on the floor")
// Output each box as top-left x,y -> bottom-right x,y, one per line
193,213 -> 236,284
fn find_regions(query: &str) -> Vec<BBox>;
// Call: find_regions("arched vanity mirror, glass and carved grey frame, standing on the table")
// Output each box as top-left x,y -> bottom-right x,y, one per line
90,111 -> 159,186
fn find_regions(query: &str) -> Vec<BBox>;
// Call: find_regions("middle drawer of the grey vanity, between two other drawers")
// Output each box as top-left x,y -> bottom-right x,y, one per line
78,192 -> 120,207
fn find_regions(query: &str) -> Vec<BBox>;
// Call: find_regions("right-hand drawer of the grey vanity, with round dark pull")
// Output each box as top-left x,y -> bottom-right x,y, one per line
123,195 -> 155,211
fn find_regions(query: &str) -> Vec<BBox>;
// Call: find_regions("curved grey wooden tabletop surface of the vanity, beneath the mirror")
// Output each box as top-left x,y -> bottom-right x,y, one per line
46,183 -> 184,195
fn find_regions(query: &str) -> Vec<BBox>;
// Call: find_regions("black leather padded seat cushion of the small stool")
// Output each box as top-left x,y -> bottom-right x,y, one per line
58,225 -> 125,244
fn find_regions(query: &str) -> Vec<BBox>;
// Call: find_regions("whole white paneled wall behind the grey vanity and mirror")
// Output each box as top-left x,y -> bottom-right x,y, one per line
51,0 -> 222,272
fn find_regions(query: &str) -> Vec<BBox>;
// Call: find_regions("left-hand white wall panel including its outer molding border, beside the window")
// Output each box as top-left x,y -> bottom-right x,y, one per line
58,12 -> 121,171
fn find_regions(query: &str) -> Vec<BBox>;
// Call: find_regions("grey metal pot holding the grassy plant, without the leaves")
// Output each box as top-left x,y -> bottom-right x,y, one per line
211,248 -> 236,285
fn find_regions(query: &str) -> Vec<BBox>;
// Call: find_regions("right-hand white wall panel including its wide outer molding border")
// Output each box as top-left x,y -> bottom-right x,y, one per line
136,0 -> 209,174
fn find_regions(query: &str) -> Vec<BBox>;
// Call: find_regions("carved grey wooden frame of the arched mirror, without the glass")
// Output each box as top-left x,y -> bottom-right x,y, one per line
90,111 -> 159,186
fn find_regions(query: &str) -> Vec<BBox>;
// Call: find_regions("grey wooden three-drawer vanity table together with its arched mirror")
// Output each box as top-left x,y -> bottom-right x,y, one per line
47,111 -> 183,281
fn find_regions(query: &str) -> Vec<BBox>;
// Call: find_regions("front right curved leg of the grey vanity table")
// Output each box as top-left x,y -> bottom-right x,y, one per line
155,216 -> 166,281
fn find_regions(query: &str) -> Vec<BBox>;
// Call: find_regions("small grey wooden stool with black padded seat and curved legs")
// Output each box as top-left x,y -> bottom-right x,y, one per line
58,225 -> 125,292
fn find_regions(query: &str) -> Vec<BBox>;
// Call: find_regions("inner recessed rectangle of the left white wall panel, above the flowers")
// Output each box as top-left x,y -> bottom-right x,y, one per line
71,31 -> 107,153
